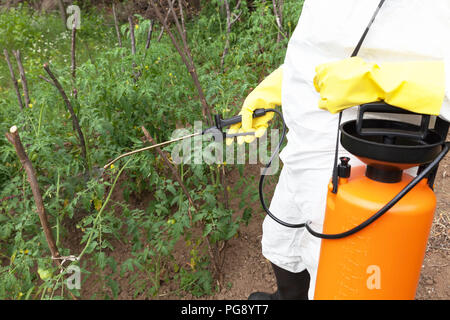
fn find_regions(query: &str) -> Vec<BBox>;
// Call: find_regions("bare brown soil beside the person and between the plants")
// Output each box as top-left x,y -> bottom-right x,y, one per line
74,132 -> 450,300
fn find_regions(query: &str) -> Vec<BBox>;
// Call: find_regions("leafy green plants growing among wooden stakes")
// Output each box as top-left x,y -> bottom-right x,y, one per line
0,0 -> 301,299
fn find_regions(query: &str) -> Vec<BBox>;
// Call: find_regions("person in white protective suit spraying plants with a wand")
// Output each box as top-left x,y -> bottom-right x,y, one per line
227,0 -> 450,299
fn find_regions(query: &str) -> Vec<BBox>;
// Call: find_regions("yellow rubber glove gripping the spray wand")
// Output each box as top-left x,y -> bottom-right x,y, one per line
226,67 -> 283,145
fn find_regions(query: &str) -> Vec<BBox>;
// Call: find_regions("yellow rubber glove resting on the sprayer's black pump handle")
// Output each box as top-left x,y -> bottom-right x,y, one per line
314,57 -> 445,115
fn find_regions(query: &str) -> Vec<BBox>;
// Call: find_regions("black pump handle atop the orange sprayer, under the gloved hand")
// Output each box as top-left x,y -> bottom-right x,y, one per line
356,102 -> 430,140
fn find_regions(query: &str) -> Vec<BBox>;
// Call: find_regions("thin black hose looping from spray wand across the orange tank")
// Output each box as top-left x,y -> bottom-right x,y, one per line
259,109 -> 450,239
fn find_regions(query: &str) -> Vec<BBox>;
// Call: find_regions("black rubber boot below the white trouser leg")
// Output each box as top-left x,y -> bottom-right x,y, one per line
248,263 -> 310,300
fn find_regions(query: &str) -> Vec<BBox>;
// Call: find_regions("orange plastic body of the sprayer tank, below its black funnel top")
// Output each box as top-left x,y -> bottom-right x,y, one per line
314,166 -> 436,300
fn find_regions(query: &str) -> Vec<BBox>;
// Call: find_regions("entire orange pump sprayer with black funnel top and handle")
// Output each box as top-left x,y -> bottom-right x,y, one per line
307,103 -> 449,300
